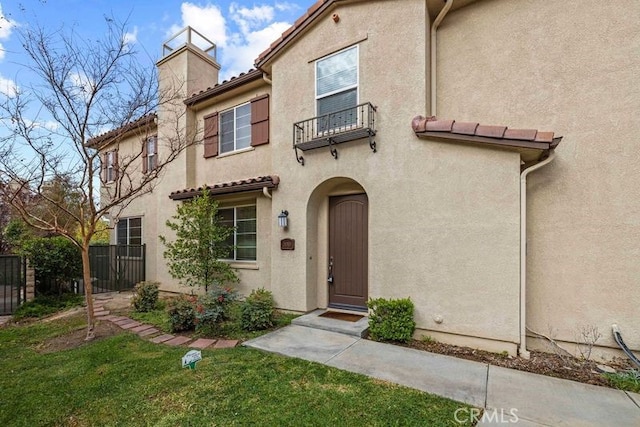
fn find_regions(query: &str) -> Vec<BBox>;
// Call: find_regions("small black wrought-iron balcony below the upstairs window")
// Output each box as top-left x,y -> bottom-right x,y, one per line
293,102 -> 376,166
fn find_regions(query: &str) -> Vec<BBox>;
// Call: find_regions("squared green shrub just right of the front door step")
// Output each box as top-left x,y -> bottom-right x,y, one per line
367,298 -> 416,342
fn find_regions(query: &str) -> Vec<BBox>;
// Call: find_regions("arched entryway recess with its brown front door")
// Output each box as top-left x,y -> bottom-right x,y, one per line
307,177 -> 369,311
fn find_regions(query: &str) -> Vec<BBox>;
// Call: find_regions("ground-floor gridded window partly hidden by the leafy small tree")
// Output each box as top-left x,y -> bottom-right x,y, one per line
218,205 -> 257,261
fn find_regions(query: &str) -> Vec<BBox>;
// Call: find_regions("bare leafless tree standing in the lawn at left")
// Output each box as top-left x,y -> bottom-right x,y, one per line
0,18 -> 192,340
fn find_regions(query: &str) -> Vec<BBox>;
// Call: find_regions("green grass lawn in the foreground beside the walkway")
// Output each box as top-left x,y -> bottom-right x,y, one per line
0,316 -> 476,426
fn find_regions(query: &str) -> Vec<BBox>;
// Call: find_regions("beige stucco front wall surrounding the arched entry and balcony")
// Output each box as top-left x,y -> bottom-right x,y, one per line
272,1 -> 519,351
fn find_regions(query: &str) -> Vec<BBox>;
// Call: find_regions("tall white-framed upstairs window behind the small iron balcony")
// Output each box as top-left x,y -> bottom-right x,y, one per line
316,46 -> 358,131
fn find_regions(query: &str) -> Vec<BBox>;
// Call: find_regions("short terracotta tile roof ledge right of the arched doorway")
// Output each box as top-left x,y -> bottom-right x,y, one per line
411,116 -> 562,150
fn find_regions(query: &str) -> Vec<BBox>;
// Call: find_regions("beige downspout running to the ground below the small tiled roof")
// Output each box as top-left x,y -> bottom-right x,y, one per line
518,150 -> 556,359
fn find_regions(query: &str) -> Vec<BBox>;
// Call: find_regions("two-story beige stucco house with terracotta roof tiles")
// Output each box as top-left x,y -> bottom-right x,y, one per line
94,0 -> 640,357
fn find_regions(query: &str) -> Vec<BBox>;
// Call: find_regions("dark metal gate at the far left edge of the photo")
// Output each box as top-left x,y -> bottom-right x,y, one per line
0,255 -> 27,315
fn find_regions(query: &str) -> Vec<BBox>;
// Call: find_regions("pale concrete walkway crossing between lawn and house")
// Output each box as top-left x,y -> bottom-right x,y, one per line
243,325 -> 640,426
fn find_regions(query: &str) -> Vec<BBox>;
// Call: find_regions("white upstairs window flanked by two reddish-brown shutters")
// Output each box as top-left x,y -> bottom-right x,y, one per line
204,94 -> 269,158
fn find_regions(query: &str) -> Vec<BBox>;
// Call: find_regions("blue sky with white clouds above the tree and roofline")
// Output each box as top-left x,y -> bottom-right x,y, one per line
0,0 -> 315,96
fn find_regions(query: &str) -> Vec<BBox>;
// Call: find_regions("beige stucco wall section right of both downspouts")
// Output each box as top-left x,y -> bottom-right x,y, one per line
438,0 -> 640,351
